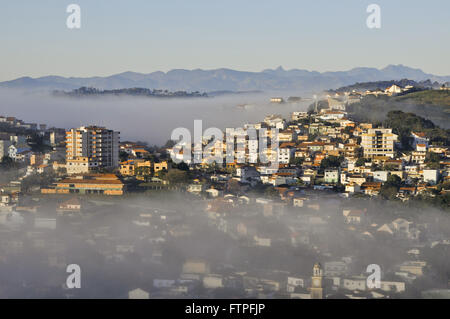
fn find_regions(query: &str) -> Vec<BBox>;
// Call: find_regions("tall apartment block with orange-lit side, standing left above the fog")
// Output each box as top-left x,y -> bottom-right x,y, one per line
66,126 -> 120,174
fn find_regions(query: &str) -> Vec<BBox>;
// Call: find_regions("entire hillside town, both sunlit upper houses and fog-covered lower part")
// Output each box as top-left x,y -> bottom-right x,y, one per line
0,85 -> 450,299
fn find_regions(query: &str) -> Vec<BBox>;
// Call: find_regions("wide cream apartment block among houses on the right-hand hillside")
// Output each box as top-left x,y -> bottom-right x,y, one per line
361,128 -> 398,158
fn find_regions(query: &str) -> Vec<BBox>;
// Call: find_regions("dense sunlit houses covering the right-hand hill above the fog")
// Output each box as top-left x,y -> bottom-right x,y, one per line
176,107 -> 450,200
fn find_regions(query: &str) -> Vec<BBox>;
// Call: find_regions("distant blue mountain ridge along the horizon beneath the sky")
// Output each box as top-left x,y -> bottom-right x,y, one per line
0,65 -> 450,92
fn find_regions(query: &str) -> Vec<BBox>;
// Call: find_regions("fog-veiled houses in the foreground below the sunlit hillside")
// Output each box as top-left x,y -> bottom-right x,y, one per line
5,178 -> 444,299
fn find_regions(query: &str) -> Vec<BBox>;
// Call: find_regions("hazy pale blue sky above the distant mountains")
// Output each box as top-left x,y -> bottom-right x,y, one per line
0,0 -> 450,80
